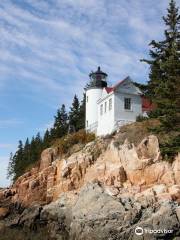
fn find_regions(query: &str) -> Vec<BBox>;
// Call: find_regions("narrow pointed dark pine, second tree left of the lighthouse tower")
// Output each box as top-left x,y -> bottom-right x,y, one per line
69,95 -> 80,131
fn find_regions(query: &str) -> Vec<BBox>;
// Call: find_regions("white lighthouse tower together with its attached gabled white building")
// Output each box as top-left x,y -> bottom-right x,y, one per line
85,67 -> 146,136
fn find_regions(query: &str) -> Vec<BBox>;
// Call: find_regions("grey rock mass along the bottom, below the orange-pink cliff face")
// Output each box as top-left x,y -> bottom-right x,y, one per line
0,182 -> 180,240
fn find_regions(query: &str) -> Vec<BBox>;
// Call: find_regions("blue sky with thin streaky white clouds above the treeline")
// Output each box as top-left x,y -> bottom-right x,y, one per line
0,0 -> 180,186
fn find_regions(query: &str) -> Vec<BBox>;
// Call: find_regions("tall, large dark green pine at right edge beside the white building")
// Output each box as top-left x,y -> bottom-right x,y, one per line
142,0 -> 180,131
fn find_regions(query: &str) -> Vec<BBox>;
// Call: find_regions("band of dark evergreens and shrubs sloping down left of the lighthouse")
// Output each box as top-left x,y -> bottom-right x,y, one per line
7,94 -> 87,181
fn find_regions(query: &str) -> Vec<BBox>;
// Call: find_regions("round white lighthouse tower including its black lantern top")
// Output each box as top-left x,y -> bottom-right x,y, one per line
85,67 -> 108,133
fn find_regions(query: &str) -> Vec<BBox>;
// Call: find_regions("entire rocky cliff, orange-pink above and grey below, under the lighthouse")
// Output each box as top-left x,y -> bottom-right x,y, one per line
0,126 -> 180,240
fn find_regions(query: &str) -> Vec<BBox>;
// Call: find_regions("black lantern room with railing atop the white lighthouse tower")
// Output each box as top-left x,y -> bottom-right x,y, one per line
87,67 -> 108,88
